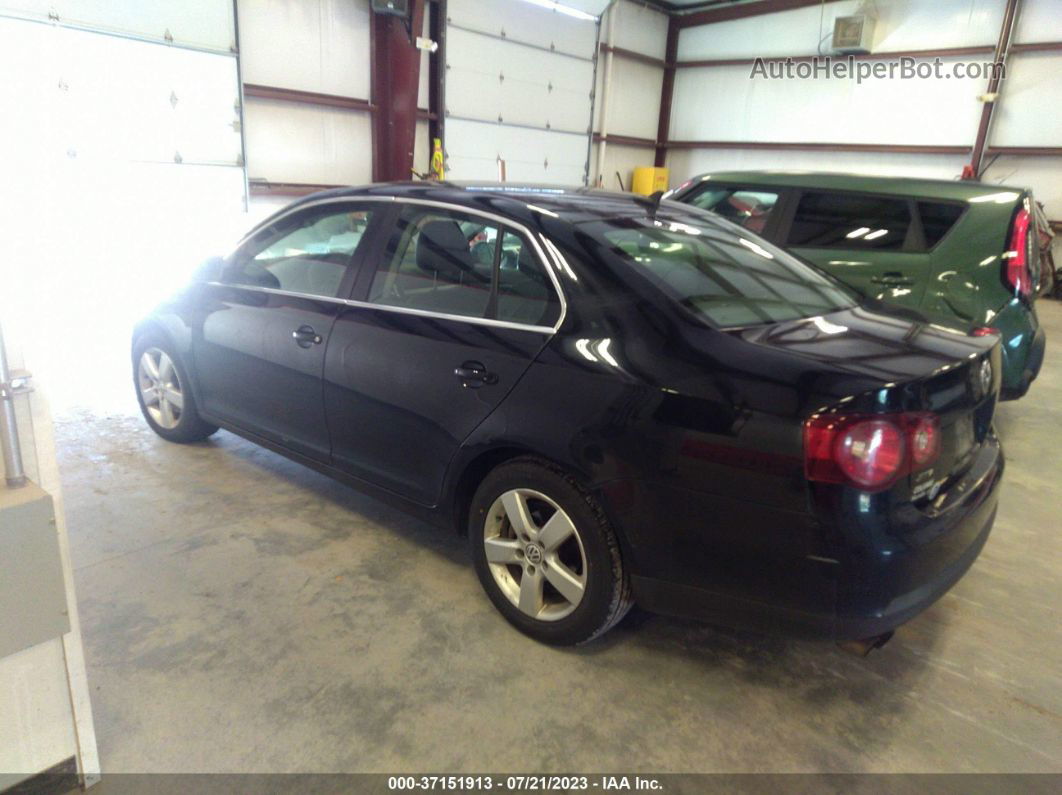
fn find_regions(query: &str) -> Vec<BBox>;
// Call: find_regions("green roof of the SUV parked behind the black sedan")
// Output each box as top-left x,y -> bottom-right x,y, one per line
675,171 -> 1027,202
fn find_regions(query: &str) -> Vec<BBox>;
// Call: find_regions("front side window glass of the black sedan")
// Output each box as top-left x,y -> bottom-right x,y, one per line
222,209 -> 372,298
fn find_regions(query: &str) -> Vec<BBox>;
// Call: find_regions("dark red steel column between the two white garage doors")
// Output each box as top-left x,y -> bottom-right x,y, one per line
372,0 -> 424,183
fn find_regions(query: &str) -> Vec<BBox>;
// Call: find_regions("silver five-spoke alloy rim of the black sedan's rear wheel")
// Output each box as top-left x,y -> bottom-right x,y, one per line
483,488 -> 587,621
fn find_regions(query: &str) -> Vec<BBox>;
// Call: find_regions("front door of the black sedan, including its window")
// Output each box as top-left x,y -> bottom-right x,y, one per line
193,202 -> 379,462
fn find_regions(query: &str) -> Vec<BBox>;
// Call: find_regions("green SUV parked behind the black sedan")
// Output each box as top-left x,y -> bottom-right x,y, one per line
667,171 -> 1045,399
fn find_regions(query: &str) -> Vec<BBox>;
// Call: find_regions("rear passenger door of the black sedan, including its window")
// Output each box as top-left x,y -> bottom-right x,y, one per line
324,202 -> 563,505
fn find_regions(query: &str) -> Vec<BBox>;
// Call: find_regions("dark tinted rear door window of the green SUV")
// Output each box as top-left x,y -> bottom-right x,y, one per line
788,193 -> 911,250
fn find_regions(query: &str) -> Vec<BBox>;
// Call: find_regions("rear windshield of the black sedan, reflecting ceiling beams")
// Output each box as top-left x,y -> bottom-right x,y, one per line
580,213 -> 857,328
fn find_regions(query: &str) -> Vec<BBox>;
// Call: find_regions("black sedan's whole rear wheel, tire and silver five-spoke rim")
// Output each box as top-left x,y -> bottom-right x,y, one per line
468,459 -> 632,645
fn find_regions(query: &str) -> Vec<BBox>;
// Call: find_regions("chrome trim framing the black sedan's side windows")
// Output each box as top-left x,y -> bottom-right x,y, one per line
229,196 -> 568,333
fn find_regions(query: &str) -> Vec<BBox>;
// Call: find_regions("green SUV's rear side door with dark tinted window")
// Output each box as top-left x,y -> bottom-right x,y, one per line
778,190 -> 935,309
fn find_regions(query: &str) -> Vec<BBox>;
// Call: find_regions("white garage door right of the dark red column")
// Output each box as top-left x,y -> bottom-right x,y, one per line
446,0 -> 604,185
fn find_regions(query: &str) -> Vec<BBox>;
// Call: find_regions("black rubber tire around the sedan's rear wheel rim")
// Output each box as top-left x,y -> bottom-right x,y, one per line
468,457 -> 633,645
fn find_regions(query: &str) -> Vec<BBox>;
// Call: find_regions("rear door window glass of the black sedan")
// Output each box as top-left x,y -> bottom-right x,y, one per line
369,205 -> 560,326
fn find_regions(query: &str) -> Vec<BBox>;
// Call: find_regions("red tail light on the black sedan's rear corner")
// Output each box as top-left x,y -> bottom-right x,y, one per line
804,412 -> 940,491
